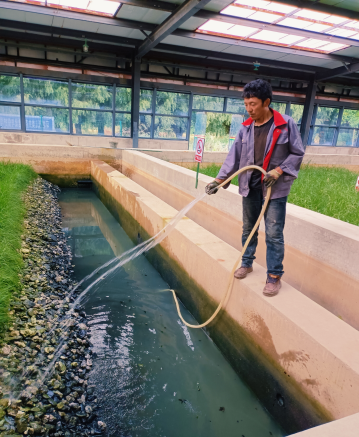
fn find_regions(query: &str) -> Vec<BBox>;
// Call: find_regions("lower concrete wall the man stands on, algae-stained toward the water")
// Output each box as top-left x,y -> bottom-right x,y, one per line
91,162 -> 359,432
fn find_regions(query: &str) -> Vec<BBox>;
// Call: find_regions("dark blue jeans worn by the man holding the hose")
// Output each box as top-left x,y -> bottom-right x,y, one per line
242,190 -> 287,276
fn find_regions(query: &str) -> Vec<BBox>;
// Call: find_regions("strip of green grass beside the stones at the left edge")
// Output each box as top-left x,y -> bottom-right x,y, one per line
0,162 -> 36,331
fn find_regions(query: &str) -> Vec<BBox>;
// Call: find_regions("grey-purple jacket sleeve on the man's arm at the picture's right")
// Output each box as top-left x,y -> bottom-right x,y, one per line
280,118 -> 305,178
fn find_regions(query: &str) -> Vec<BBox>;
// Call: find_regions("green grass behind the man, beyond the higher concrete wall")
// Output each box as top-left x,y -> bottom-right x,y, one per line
192,164 -> 359,226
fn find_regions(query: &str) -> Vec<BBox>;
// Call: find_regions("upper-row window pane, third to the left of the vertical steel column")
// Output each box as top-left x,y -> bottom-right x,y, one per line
24,78 -> 69,106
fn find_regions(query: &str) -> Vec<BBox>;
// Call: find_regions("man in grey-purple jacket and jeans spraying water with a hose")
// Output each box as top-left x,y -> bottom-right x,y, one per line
206,79 -> 304,296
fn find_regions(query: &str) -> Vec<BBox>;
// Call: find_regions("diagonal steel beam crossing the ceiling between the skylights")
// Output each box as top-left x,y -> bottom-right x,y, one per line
136,0 -> 210,58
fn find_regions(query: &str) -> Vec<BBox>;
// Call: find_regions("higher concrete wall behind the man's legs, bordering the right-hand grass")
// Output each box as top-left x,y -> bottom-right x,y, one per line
119,151 -> 359,329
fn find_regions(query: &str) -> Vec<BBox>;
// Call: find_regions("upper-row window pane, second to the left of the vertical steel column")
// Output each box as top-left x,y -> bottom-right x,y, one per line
72,83 -> 113,109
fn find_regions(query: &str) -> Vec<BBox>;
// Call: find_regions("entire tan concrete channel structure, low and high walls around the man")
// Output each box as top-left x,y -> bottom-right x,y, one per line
1,146 -> 359,437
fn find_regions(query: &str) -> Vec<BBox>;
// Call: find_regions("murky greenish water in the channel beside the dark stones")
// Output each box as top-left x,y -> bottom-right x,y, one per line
60,189 -> 284,437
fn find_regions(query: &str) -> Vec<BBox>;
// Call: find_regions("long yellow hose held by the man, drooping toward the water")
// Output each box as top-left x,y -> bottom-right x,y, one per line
171,165 -> 272,328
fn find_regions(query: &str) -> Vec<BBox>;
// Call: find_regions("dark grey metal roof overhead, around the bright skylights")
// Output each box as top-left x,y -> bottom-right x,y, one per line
0,0 -> 359,84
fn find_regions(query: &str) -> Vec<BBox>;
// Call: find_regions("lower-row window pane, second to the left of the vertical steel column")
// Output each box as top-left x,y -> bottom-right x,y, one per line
72,110 -> 112,136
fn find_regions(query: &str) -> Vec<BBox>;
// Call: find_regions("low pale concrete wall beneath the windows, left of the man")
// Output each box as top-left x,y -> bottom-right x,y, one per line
0,132 -> 188,150
